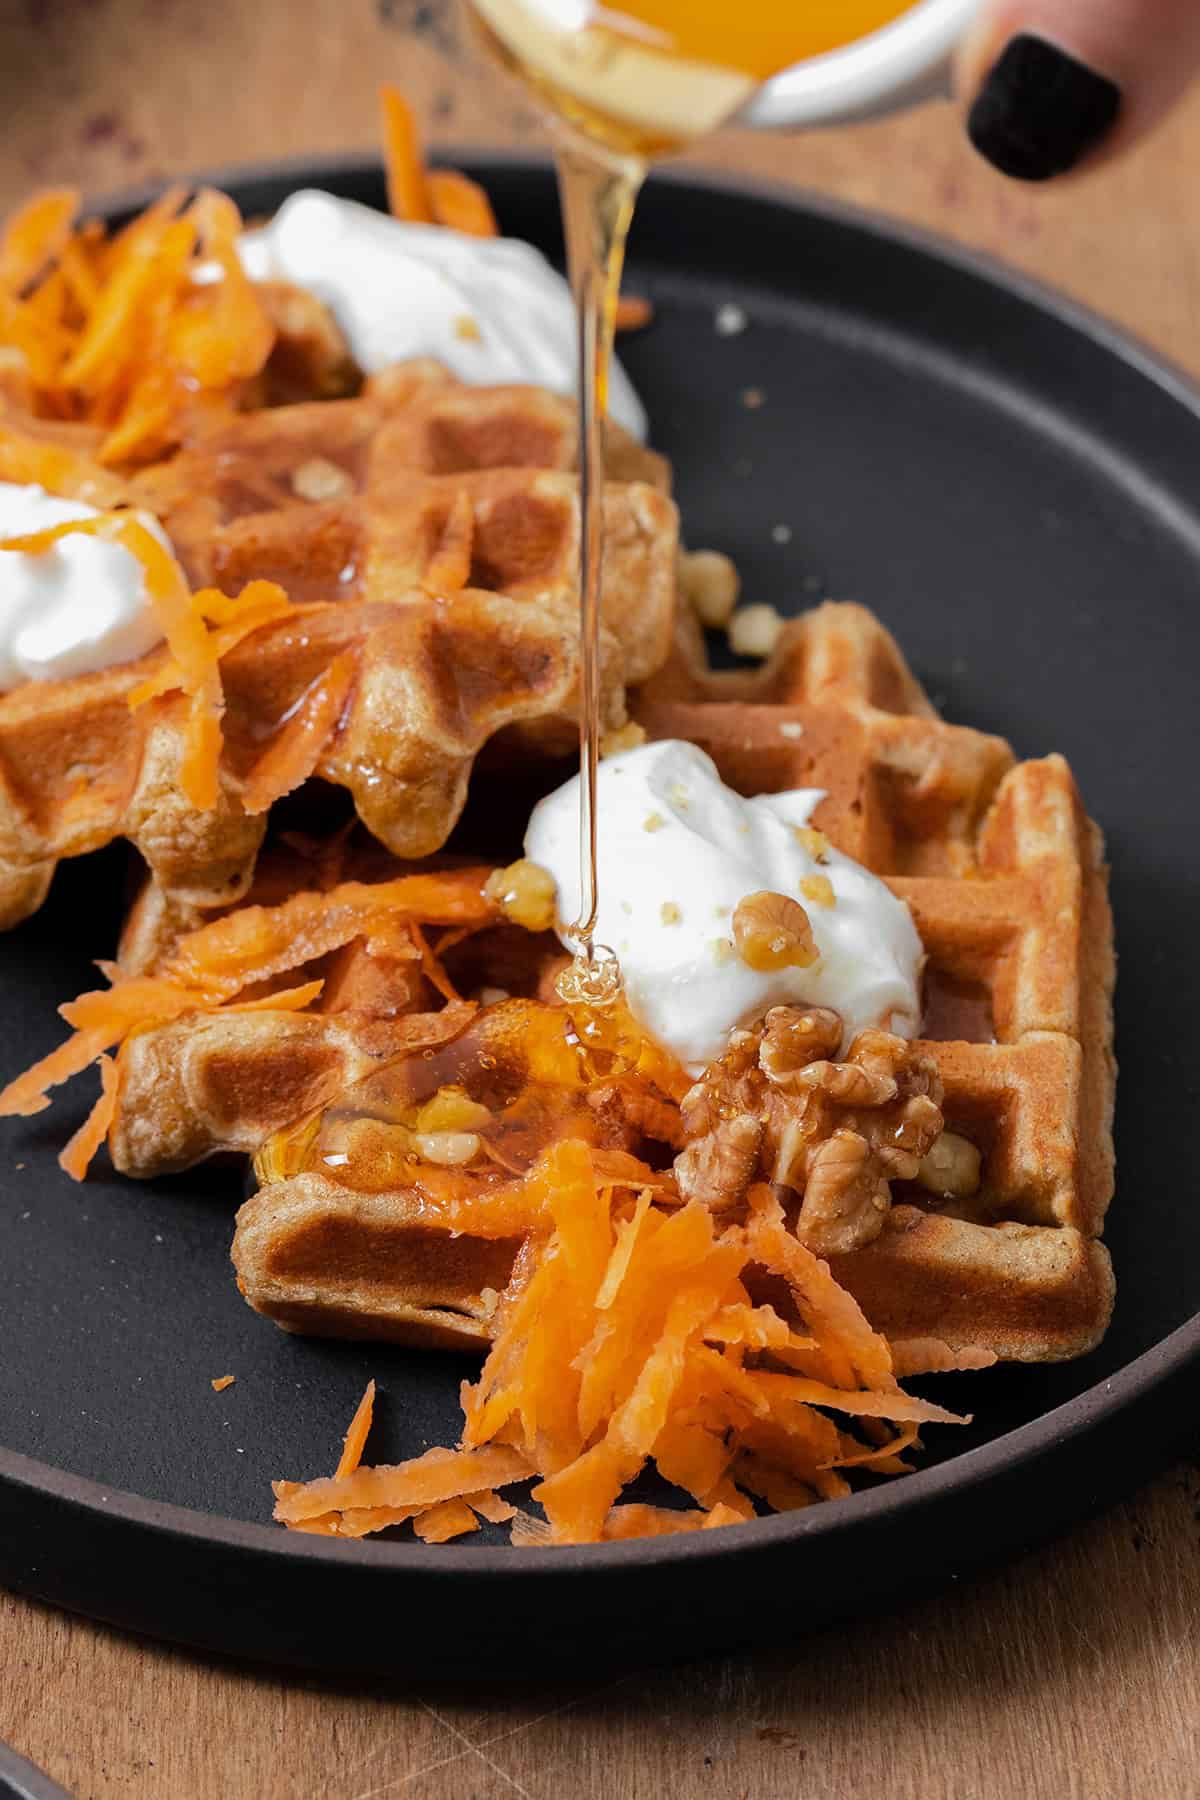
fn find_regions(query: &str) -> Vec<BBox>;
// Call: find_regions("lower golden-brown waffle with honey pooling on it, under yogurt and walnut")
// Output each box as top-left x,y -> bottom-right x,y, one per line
112,607 -> 1114,1361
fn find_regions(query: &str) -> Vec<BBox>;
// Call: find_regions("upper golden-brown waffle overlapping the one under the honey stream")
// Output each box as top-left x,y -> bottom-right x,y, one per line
0,374 -> 676,950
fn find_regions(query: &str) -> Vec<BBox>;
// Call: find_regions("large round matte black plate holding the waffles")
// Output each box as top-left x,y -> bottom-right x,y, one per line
0,158 -> 1200,1672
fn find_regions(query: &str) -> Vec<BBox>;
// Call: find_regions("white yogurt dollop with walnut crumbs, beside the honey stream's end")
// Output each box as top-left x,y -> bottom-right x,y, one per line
525,740 -> 923,1071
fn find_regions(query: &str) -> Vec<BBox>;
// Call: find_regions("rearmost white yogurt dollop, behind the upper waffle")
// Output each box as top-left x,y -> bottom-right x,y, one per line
237,187 -> 646,439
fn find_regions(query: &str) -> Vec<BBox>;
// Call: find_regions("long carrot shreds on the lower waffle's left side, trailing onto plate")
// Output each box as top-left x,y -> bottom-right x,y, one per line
0,868 -> 497,1181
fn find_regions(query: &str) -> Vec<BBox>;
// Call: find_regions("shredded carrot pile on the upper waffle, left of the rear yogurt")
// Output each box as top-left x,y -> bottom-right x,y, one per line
0,187 -> 275,466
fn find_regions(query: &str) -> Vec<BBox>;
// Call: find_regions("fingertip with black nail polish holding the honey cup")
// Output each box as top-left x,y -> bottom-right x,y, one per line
957,0 -> 1200,182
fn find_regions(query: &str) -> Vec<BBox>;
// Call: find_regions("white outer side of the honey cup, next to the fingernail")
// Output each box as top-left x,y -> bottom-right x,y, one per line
738,0 -> 981,130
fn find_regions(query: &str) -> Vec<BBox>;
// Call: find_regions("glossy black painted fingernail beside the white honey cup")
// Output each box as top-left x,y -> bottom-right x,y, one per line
966,32 -> 1121,182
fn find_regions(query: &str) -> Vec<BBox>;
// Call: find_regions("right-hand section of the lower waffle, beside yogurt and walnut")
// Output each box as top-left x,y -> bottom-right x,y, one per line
637,605 -> 1115,1361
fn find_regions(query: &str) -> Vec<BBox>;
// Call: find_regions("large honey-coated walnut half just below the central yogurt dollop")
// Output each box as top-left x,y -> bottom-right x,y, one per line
675,1006 -> 964,1256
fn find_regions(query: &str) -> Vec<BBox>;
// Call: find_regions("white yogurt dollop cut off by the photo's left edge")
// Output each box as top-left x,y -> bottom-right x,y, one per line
0,481 -> 171,689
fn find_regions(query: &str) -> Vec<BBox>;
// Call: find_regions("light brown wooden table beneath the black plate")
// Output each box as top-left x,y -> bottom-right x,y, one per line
0,0 -> 1200,1800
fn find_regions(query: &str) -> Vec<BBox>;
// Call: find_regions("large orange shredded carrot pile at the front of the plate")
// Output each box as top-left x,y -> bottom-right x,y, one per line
275,1139 -> 964,1544
